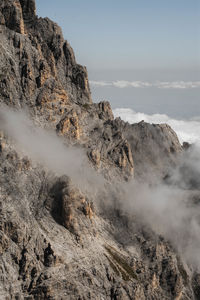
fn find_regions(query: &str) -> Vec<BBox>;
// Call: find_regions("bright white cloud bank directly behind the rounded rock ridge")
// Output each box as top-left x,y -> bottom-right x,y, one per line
113,108 -> 200,143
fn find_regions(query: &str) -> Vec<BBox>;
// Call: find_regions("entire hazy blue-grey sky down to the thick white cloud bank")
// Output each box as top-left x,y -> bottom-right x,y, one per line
36,0 -> 200,117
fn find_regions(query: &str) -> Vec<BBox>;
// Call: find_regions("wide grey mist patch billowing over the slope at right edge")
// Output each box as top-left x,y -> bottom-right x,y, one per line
112,142 -> 200,271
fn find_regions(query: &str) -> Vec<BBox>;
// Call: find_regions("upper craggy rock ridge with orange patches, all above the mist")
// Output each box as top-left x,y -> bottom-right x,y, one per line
0,0 -> 178,179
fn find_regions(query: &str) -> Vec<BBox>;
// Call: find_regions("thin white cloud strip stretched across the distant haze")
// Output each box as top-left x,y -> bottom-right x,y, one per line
90,80 -> 200,89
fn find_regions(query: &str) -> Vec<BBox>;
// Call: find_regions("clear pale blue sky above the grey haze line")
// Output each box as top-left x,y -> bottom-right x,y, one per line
36,0 -> 200,69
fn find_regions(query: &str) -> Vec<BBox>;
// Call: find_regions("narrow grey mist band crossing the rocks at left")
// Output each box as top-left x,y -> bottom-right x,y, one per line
0,107 -> 103,193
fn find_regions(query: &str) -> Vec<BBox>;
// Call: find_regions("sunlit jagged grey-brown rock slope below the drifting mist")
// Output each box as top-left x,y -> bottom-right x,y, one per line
0,137 -> 195,300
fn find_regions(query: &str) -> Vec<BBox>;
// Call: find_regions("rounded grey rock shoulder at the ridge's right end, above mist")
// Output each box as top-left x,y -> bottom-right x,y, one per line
112,118 -> 182,179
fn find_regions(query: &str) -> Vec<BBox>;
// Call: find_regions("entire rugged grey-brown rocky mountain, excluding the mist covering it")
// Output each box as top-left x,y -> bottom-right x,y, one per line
0,0 -> 200,300
